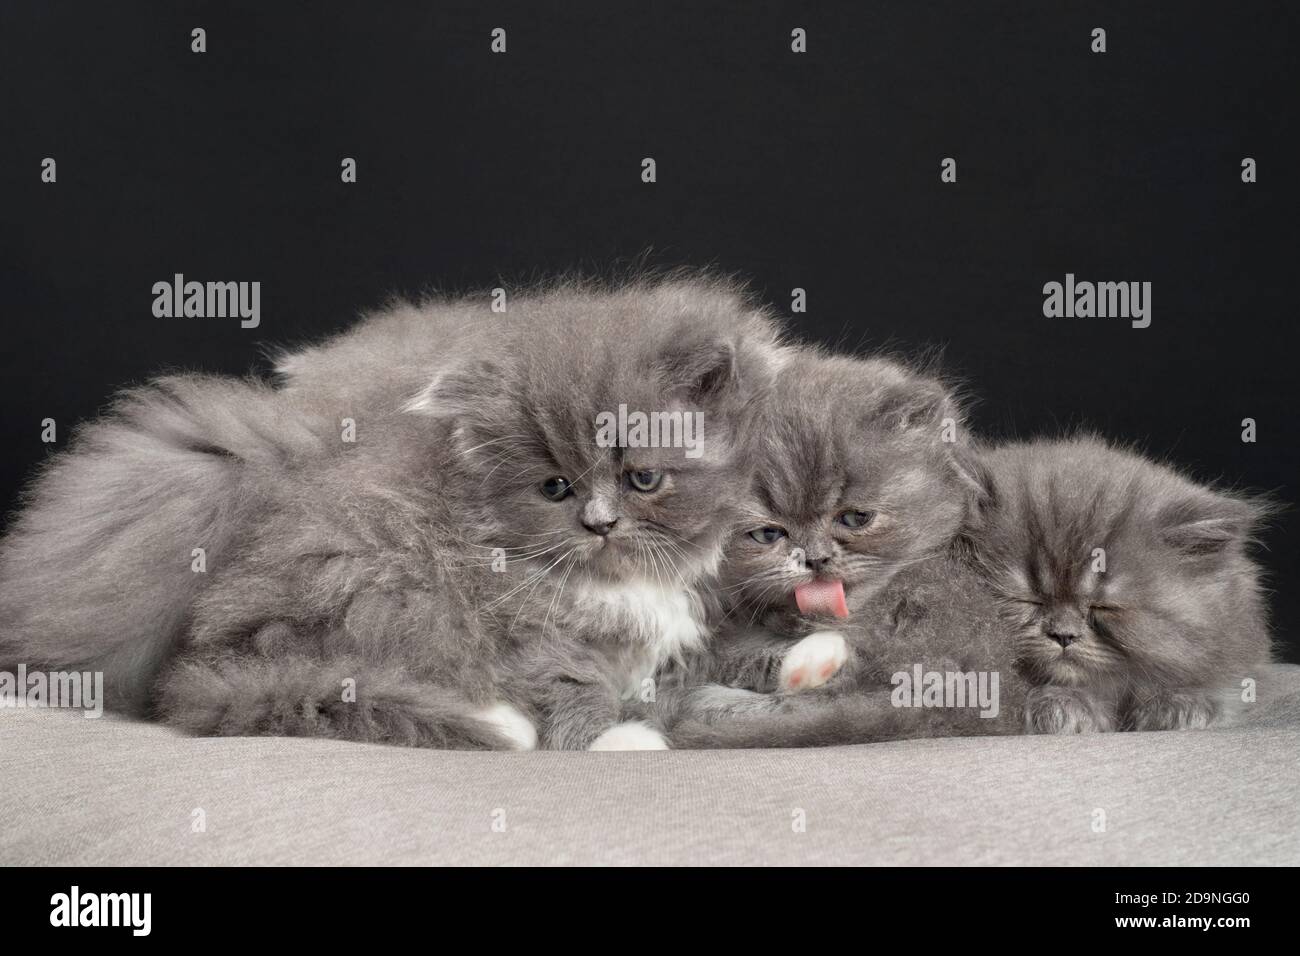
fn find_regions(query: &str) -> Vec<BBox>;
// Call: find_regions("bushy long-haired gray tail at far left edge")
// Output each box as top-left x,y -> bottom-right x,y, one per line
0,375 -> 330,711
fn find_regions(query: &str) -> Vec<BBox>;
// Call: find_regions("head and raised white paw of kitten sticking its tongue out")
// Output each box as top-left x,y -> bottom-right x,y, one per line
701,350 -> 974,692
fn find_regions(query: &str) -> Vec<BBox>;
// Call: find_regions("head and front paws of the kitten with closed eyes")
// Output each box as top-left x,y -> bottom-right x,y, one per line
971,437 -> 1269,732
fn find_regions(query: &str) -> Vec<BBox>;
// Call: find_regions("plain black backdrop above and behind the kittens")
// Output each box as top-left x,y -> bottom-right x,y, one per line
0,0 -> 1300,659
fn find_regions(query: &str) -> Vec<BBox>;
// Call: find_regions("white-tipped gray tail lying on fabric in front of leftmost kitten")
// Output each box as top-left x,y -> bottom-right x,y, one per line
157,656 -> 537,750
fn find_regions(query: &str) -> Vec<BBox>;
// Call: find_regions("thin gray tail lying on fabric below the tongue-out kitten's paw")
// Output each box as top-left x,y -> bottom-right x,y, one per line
670,688 -> 1017,749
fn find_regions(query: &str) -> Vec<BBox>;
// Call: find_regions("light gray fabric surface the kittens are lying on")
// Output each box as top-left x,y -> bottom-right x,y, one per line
0,667 -> 1300,865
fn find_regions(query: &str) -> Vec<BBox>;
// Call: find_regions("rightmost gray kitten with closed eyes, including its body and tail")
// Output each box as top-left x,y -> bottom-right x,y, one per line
673,436 -> 1269,747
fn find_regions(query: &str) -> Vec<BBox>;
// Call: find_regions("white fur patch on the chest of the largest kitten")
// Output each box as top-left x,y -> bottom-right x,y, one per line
580,581 -> 706,670
